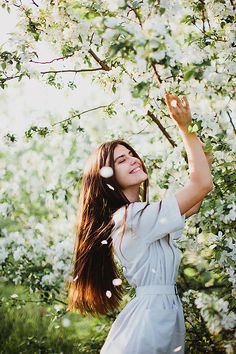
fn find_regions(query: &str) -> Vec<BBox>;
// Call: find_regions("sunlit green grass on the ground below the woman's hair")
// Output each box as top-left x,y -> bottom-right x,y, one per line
0,284 -> 110,354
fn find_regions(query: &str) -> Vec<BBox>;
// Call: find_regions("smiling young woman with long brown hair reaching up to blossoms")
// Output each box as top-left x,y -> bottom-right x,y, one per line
68,93 -> 213,354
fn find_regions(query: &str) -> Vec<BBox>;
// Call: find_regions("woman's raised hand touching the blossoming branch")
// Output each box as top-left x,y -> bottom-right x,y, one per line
164,92 -> 192,128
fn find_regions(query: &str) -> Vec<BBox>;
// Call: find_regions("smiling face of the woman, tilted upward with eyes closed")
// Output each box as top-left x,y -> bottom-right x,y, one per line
114,145 -> 148,191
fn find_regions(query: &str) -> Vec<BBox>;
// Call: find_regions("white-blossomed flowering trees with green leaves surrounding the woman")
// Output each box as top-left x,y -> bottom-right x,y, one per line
0,0 -> 236,353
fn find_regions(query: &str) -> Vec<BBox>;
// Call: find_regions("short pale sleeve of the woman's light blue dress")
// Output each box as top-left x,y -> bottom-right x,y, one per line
127,193 -> 185,244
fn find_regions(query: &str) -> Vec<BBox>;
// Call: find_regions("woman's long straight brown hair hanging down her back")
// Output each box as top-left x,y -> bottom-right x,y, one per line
68,140 -> 148,316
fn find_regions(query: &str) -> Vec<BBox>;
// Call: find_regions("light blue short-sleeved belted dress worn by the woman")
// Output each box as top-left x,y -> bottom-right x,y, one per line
100,192 -> 186,354
